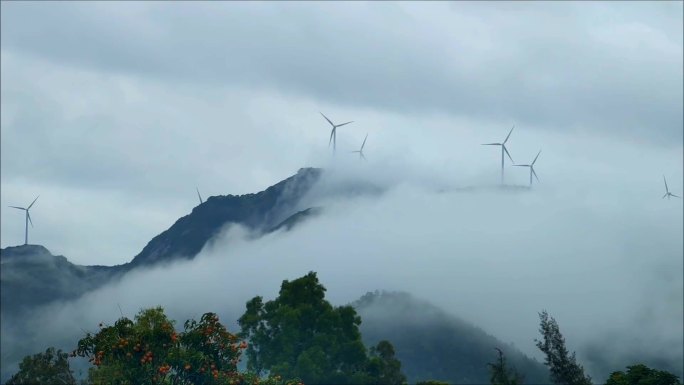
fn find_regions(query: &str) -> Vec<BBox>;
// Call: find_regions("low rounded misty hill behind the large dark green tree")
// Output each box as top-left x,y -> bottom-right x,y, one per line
352,292 -> 549,384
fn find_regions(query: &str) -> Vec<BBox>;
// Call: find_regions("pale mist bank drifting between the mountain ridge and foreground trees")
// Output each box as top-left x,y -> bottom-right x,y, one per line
3,143 -> 684,378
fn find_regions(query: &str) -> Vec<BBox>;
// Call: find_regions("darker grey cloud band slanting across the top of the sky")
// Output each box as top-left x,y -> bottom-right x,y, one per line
3,3 -> 683,145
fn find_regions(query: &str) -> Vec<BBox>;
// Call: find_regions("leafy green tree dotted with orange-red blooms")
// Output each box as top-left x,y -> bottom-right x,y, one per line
72,307 -> 296,385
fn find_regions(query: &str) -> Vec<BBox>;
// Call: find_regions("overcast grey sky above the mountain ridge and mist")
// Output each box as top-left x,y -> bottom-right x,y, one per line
0,2 -> 683,264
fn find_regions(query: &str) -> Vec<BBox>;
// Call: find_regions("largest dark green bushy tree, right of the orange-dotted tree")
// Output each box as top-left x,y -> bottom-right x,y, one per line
238,272 -> 398,384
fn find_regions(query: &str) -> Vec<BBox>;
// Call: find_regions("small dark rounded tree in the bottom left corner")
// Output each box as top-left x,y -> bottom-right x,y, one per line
6,347 -> 76,385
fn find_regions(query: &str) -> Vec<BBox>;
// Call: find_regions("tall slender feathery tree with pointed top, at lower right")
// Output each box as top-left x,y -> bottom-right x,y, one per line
535,310 -> 591,385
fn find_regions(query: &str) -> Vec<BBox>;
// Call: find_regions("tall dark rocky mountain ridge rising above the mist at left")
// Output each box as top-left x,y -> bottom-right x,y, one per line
0,168 -> 322,316
